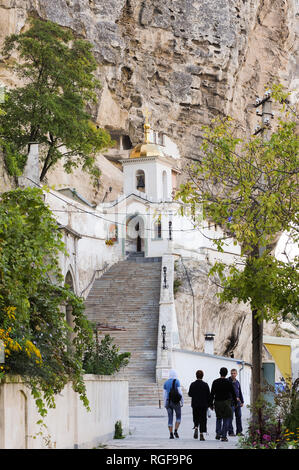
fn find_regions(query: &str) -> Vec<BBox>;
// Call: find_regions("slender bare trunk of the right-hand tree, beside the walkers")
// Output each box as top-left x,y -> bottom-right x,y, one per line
251,309 -> 263,403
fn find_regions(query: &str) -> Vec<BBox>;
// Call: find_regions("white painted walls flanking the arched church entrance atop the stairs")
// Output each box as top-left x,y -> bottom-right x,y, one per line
44,184 -> 244,298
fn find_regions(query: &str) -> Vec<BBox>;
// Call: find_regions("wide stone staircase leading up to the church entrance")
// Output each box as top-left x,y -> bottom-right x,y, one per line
85,253 -> 189,407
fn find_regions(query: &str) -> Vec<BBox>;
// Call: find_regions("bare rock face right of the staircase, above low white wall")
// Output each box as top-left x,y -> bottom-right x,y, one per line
175,258 -> 298,363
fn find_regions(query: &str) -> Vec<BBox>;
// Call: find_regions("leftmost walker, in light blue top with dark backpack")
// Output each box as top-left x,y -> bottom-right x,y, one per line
163,369 -> 184,439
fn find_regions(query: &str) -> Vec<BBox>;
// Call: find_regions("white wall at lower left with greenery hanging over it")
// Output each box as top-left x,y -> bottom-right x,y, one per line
0,374 -> 129,449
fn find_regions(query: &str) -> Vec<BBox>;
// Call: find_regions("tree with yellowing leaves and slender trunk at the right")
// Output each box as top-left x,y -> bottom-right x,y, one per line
177,87 -> 298,400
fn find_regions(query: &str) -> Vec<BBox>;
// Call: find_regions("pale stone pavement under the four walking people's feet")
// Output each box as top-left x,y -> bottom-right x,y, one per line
105,405 -> 249,449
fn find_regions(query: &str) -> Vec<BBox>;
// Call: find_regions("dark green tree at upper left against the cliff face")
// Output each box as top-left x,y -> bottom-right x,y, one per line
0,19 -> 112,181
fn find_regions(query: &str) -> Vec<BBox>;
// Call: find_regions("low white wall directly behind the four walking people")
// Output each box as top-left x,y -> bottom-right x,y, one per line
172,349 -> 251,406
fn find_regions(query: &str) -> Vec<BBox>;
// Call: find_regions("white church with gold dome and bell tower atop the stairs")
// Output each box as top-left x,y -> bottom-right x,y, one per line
96,117 -> 240,259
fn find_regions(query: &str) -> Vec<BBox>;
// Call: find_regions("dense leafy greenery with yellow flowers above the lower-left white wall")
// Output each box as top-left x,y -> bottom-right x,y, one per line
0,188 -> 94,415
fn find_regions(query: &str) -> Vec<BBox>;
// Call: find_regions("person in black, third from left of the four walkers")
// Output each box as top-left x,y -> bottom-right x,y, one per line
210,367 -> 237,441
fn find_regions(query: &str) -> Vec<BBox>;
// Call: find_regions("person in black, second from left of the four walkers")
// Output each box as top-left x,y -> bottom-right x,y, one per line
188,370 -> 210,441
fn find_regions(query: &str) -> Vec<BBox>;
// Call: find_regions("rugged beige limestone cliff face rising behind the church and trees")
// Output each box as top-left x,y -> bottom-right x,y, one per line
0,0 -> 298,360
